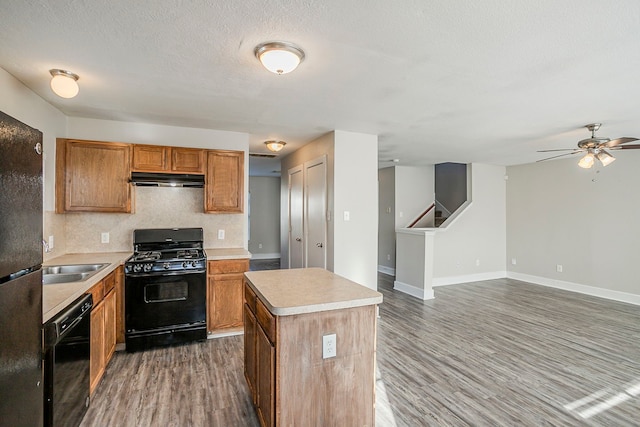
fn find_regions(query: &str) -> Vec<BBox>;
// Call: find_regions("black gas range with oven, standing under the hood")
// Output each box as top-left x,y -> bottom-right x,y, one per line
125,228 -> 207,351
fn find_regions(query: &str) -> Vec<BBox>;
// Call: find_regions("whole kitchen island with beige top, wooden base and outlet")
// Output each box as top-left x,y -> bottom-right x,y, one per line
244,268 -> 382,426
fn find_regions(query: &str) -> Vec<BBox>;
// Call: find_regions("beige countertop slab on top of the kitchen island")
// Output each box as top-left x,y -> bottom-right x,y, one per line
245,268 -> 382,316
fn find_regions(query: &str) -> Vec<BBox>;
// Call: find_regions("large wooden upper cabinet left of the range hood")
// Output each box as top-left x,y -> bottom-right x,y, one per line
56,138 -> 131,213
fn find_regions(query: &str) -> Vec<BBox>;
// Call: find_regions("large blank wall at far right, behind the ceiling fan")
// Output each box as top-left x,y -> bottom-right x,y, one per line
507,155 -> 640,303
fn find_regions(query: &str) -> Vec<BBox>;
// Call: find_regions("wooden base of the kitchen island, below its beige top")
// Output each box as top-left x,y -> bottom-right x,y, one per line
244,284 -> 376,427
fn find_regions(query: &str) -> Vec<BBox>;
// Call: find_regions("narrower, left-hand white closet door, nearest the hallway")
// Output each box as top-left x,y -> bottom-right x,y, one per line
289,166 -> 304,268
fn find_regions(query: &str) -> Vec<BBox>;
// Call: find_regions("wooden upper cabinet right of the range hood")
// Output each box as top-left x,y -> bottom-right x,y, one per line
204,150 -> 244,213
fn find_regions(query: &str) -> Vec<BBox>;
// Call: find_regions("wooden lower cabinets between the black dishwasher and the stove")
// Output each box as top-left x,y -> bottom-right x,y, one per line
89,267 -> 122,394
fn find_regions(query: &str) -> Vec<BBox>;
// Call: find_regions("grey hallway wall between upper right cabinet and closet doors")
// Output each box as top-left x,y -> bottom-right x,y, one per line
249,176 -> 280,259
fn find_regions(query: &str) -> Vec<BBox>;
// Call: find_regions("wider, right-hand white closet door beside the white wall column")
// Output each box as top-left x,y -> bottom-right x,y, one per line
304,156 -> 327,268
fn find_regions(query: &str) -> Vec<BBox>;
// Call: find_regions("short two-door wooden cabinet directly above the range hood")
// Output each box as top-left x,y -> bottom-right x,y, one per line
131,144 -> 205,174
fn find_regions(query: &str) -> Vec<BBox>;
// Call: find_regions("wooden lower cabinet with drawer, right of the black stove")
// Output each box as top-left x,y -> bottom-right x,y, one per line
207,259 -> 249,334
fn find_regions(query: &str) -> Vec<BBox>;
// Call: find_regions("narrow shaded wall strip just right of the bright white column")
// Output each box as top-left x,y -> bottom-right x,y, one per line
378,167 -> 396,275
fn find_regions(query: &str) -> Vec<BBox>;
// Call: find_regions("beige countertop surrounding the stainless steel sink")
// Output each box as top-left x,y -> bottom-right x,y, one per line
42,252 -> 131,323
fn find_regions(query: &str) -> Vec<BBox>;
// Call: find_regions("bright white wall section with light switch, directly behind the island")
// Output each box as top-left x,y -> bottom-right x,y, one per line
333,130 -> 378,289
